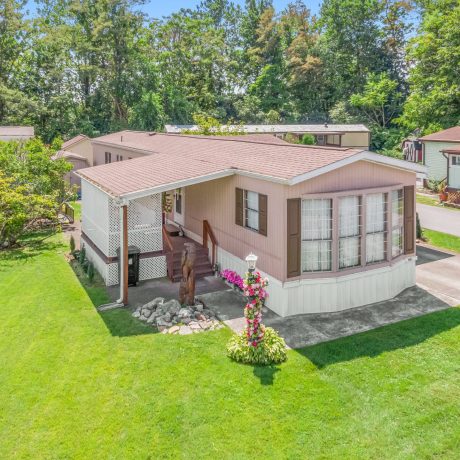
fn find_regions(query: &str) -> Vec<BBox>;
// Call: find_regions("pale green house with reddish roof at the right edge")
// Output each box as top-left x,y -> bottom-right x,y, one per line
419,126 -> 460,189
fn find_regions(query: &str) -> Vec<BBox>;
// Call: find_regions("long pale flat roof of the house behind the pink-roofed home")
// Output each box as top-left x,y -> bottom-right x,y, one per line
165,123 -> 369,134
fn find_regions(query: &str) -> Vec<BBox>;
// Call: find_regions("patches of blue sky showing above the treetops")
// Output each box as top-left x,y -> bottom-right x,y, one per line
27,0 -> 321,18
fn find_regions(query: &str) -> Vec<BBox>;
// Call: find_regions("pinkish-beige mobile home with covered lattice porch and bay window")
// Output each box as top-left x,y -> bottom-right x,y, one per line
78,131 -> 425,316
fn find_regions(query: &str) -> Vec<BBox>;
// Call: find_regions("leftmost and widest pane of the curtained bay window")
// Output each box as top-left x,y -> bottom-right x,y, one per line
301,199 -> 332,272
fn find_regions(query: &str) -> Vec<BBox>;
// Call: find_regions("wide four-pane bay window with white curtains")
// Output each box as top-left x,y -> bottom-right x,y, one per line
296,188 -> 405,274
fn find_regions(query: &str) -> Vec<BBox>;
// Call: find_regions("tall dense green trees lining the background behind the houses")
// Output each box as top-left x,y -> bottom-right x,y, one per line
0,0 -> 460,151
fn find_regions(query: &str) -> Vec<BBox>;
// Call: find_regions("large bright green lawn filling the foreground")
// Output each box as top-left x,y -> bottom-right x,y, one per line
0,237 -> 460,459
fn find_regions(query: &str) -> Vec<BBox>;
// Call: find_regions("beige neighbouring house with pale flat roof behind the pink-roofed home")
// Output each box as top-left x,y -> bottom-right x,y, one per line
165,123 -> 371,149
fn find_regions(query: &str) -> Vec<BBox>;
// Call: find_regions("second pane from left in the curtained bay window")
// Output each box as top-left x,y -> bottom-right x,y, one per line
339,196 -> 361,268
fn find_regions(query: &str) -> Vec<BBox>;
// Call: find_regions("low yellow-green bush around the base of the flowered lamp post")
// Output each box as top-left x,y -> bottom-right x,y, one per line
227,327 -> 287,365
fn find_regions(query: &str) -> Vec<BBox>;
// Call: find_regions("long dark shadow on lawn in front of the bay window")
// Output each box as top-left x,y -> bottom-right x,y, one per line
295,308 -> 460,369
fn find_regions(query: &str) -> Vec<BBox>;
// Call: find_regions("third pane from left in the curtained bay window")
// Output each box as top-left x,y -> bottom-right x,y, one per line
366,193 -> 387,263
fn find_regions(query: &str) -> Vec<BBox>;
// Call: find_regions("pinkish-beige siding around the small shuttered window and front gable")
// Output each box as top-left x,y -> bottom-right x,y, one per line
185,161 -> 415,281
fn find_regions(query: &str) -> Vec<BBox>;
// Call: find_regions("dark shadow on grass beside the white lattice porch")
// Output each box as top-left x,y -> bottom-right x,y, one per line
70,260 -> 158,337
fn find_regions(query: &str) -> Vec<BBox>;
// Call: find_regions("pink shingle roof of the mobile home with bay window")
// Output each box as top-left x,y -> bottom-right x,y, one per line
79,131 -> 420,196
